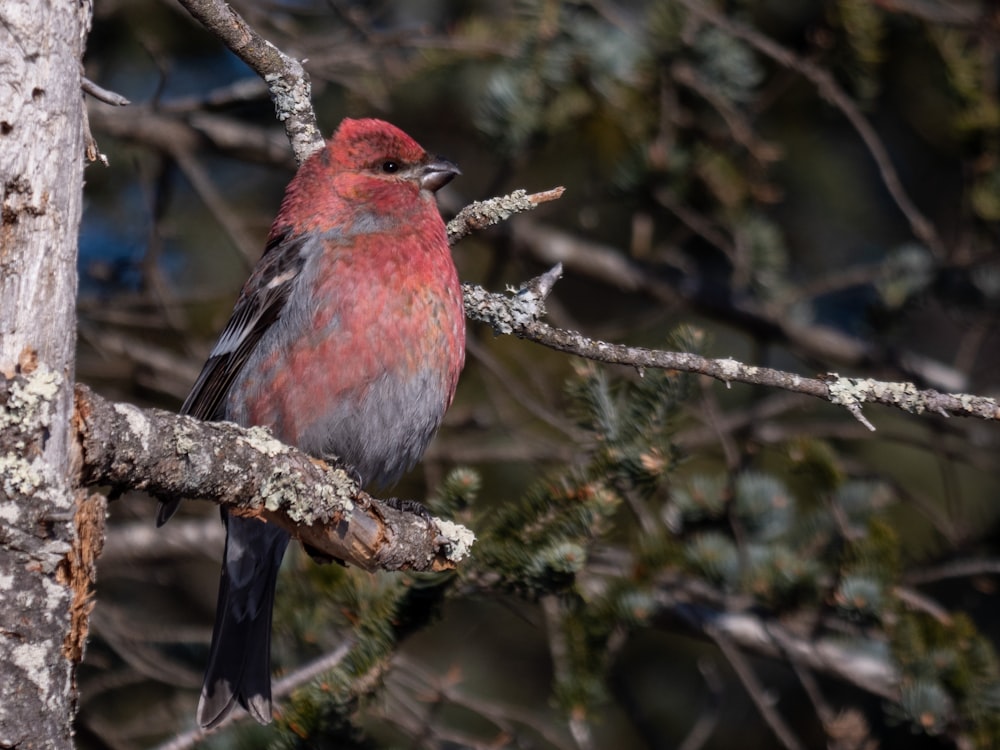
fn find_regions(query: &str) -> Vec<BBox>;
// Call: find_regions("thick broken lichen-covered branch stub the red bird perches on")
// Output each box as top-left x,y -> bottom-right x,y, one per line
74,386 -> 473,570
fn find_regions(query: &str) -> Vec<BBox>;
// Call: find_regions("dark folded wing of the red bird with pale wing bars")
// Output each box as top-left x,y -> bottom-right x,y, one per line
181,232 -> 307,420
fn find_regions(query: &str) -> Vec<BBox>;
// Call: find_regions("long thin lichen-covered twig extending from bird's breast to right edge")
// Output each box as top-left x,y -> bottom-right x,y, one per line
463,265 -> 1000,429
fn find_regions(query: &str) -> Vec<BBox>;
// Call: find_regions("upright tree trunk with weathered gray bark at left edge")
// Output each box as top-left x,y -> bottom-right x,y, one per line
0,0 -> 94,748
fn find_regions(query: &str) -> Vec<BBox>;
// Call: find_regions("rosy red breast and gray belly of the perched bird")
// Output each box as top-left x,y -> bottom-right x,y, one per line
229,219 -> 465,484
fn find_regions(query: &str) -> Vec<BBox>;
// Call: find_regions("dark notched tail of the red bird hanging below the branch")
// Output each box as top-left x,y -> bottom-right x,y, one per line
198,511 -> 289,729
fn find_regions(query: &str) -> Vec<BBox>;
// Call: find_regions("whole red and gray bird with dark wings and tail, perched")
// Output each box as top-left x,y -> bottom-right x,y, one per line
157,120 -> 465,728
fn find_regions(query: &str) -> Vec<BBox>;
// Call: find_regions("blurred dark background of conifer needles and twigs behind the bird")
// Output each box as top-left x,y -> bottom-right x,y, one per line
77,0 -> 1000,750
